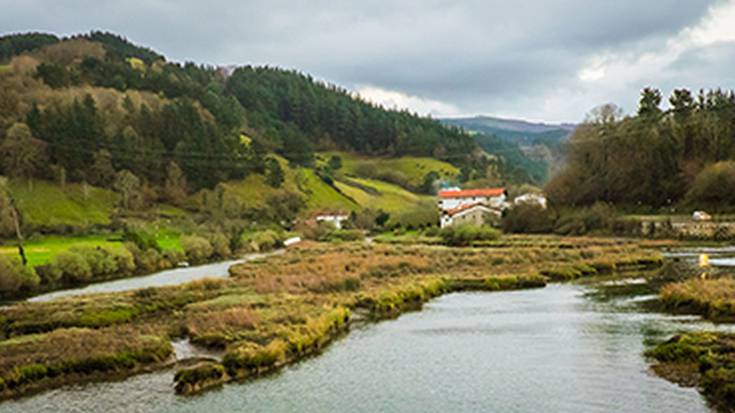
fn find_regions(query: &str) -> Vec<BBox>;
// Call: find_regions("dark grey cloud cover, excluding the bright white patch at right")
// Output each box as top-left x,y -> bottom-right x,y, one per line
0,0 -> 718,121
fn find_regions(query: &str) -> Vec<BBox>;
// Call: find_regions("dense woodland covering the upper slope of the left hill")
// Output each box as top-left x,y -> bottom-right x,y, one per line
0,32 -> 492,191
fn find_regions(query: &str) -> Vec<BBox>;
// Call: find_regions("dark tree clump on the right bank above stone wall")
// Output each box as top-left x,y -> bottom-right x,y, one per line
546,88 -> 735,209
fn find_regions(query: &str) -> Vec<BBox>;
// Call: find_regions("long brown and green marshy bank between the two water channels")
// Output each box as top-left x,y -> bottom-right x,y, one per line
0,237 -> 659,397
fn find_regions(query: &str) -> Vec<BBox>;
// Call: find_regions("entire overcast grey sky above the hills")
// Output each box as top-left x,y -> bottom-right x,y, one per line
0,0 -> 735,122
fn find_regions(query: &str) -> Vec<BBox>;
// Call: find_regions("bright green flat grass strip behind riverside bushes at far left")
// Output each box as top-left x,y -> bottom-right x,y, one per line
0,234 -> 124,266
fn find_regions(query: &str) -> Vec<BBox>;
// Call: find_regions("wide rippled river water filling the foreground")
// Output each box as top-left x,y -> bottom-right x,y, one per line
0,277 -> 723,413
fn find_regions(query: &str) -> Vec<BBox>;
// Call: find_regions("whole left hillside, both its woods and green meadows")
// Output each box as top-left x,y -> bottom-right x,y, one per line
0,32 -> 527,237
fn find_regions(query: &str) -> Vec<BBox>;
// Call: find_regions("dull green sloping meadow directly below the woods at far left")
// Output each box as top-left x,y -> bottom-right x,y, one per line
10,180 -> 117,228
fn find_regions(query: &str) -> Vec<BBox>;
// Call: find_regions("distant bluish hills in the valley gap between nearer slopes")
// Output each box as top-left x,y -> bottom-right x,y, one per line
441,116 -> 577,185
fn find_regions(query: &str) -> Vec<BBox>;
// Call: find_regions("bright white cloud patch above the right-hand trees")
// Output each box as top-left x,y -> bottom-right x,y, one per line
549,1 -> 735,116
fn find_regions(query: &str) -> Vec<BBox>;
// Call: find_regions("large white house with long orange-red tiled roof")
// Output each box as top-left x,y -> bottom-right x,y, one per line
438,188 -> 508,228
